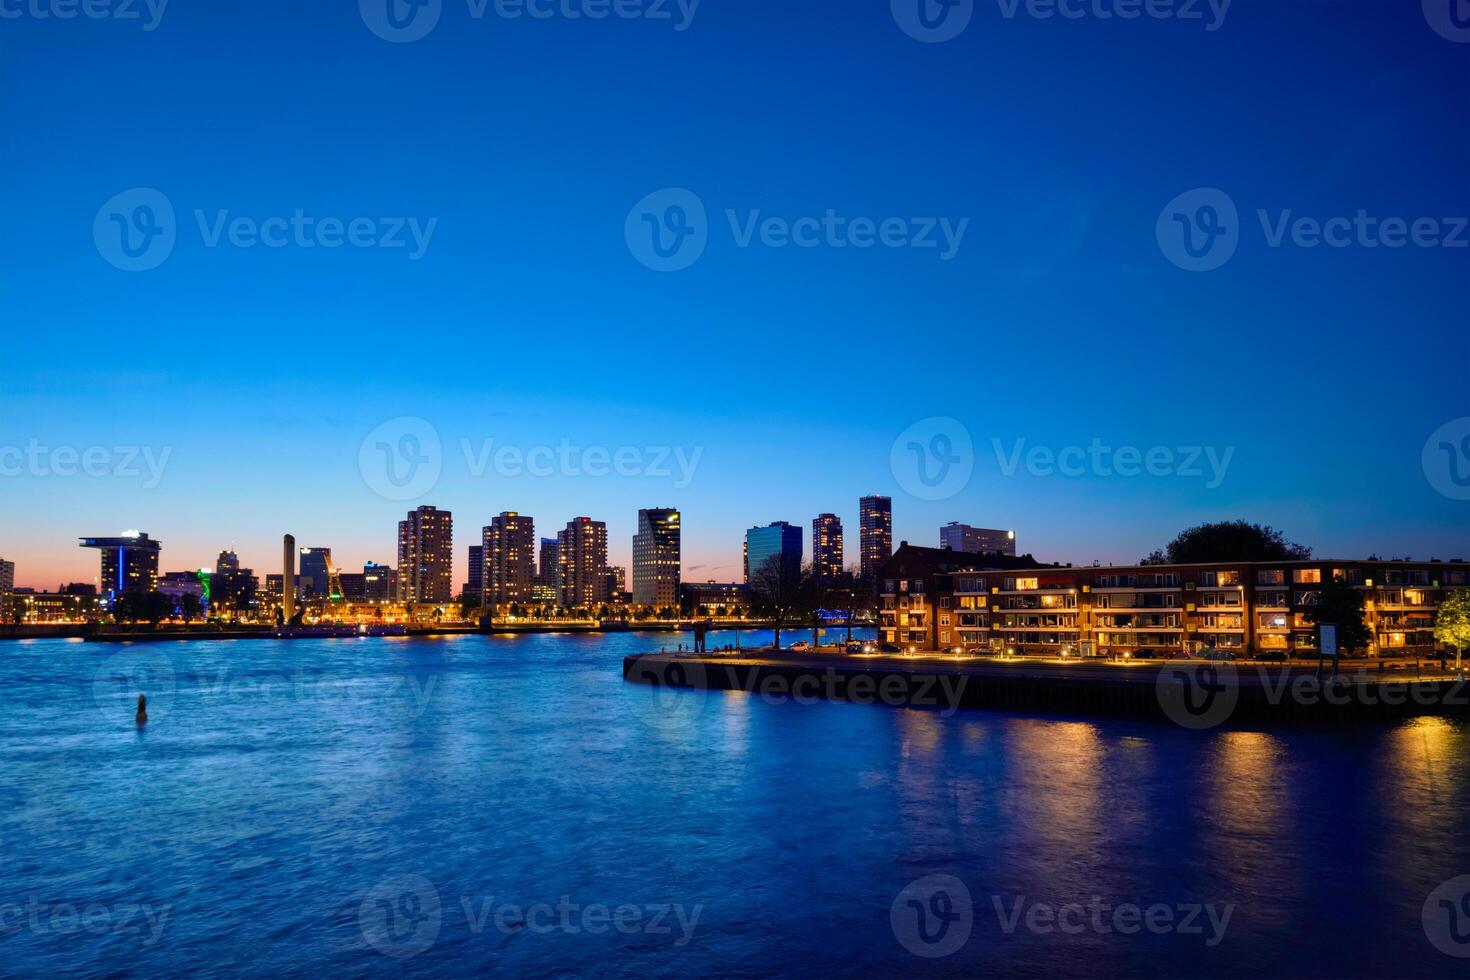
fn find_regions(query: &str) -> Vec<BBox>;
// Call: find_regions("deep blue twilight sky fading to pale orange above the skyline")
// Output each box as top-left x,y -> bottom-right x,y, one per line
0,0 -> 1470,588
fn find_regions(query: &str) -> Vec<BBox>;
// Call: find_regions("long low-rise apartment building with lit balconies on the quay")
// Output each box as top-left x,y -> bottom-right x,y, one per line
879,548 -> 1470,657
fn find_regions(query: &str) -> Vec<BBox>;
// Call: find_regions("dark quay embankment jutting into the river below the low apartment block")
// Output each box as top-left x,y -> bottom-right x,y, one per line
623,652 -> 1470,729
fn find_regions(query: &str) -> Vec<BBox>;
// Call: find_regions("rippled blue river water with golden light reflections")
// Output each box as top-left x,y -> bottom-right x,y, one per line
0,635 -> 1470,977
